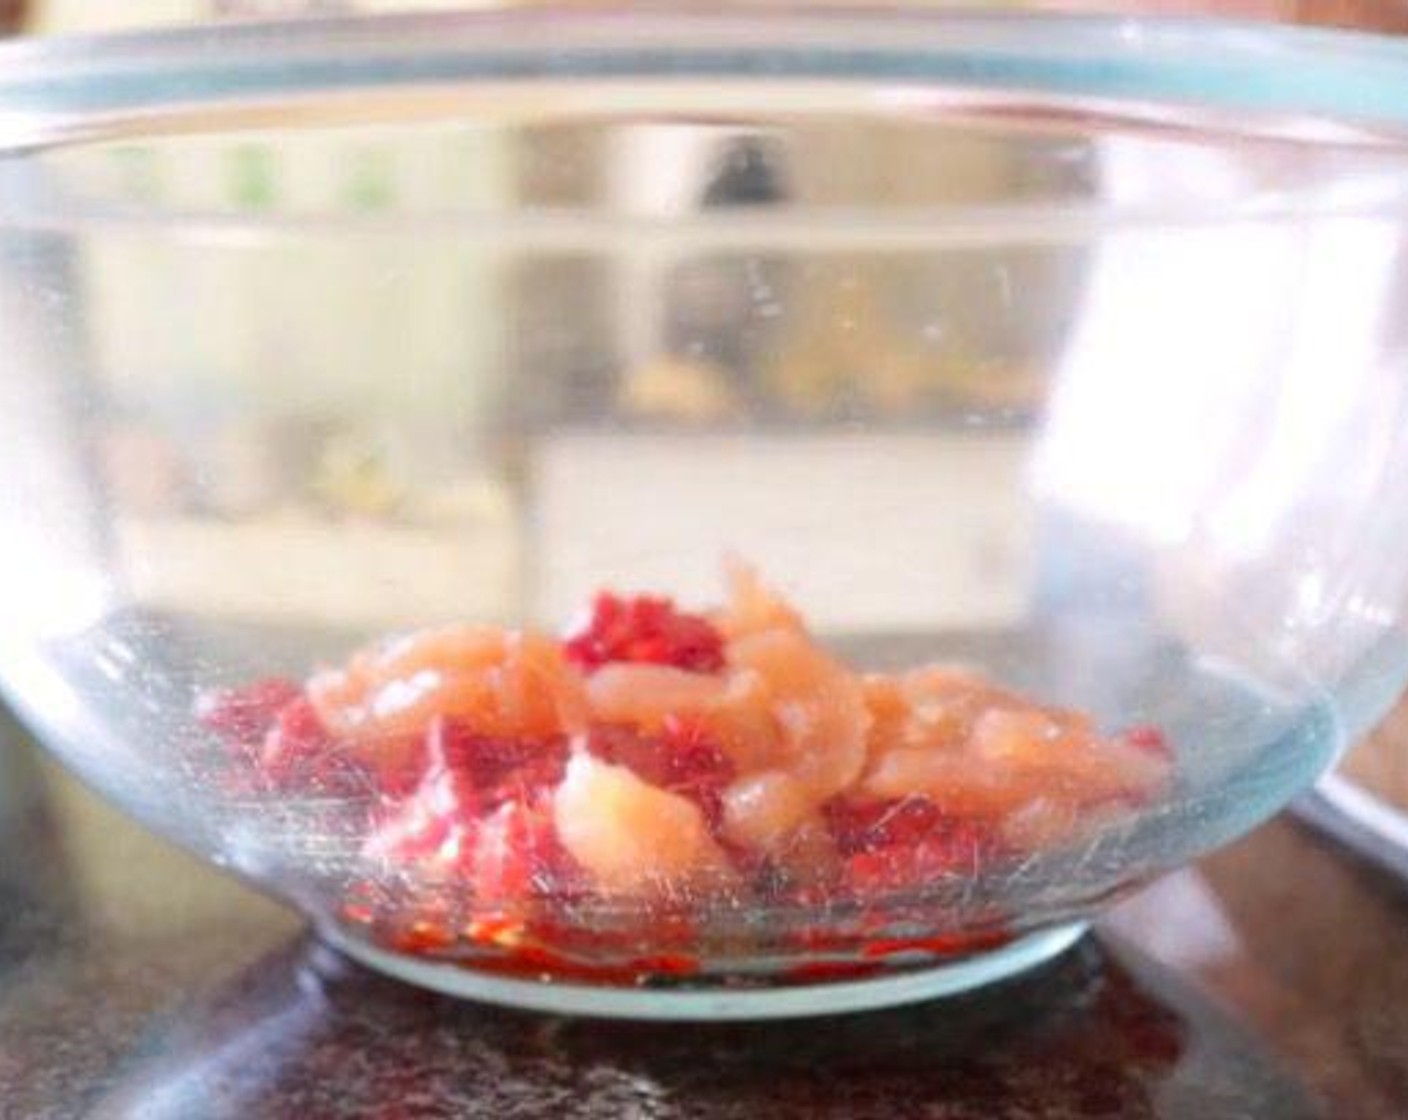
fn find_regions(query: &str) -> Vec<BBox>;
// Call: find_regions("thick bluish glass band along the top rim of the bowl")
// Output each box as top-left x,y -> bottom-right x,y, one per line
0,6 -> 1408,135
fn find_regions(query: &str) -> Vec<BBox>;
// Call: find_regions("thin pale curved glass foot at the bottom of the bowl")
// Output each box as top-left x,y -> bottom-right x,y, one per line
320,921 -> 1087,1021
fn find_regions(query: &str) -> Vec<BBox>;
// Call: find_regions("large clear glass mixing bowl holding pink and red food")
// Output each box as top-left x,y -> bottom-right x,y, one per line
0,13 -> 1408,1017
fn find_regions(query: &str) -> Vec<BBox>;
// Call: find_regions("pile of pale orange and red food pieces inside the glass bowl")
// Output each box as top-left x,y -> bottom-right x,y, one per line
199,564 -> 1174,983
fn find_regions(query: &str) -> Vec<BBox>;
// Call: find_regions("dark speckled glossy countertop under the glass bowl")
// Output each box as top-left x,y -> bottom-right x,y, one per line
0,734 -> 1408,1120
